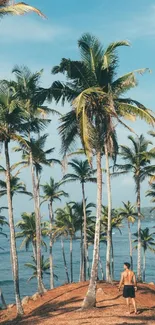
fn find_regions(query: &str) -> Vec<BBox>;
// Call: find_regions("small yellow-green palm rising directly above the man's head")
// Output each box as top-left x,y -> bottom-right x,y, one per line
120,201 -> 137,270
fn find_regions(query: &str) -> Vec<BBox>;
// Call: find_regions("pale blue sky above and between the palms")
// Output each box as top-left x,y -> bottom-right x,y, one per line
0,0 -> 155,218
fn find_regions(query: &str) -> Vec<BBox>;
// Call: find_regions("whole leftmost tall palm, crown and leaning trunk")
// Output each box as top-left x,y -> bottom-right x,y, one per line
0,85 -> 30,315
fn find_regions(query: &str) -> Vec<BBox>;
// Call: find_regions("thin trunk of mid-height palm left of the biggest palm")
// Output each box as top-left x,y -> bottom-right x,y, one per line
82,183 -> 87,281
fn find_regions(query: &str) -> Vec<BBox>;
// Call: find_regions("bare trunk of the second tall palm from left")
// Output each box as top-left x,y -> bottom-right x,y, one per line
30,151 -> 45,294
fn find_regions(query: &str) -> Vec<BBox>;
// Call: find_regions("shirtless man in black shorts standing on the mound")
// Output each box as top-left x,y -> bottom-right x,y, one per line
118,263 -> 137,314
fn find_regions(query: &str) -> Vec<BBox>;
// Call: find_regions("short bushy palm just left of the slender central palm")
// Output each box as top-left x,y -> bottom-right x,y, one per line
56,203 -> 81,283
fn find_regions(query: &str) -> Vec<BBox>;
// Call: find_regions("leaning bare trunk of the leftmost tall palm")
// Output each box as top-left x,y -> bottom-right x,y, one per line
4,141 -> 24,315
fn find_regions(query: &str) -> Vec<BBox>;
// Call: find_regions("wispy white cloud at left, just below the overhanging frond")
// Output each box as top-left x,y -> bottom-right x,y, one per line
0,17 -> 70,44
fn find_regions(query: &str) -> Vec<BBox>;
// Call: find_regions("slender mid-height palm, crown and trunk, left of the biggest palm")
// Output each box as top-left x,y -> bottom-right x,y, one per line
63,159 -> 97,281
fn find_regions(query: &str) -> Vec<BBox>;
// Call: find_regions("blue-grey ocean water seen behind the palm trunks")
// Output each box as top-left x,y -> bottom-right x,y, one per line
0,211 -> 155,304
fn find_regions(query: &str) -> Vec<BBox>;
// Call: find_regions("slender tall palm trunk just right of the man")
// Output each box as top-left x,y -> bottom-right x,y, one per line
137,180 -> 142,282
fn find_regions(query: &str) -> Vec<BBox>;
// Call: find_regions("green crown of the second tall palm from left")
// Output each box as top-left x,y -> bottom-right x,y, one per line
6,66 -> 60,136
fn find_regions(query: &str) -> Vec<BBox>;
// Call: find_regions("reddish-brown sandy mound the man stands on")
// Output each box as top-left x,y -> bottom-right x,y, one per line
0,283 -> 155,325
